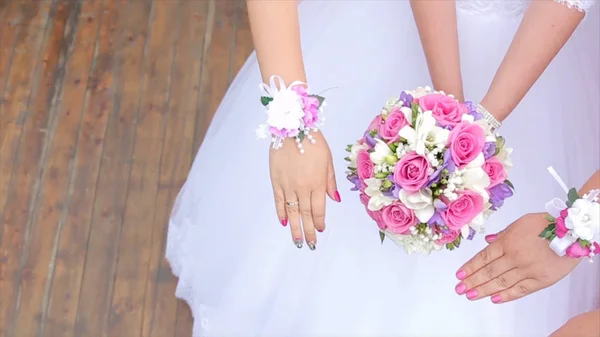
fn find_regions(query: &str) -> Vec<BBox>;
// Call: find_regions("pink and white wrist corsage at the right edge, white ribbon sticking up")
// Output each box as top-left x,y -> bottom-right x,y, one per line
540,167 -> 600,262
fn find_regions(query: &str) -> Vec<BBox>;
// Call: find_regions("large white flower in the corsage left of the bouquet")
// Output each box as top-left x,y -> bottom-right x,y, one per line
267,88 -> 304,130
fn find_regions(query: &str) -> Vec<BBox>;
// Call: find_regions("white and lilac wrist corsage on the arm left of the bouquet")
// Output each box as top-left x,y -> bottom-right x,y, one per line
256,76 -> 325,153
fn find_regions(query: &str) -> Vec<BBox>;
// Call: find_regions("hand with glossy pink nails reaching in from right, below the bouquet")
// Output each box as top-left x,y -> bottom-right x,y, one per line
456,213 -> 580,303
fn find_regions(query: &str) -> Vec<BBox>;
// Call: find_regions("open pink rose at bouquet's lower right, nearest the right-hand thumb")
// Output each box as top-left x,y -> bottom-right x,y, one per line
442,190 -> 483,231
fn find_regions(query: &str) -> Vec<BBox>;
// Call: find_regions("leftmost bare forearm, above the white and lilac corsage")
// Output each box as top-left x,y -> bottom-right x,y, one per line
247,0 -> 306,84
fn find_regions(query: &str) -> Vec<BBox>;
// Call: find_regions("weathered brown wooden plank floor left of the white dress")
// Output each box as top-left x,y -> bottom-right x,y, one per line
0,0 -> 252,337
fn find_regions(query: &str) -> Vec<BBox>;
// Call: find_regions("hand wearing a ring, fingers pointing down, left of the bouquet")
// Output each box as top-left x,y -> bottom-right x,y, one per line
269,132 -> 341,250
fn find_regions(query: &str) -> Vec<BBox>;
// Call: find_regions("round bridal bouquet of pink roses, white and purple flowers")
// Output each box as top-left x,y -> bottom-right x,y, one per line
346,88 -> 514,254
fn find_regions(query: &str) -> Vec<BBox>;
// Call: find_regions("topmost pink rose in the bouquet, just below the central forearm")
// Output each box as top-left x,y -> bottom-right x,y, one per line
419,94 -> 469,126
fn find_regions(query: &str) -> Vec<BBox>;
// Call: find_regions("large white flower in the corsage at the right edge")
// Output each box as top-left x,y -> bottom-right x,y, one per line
565,199 -> 600,241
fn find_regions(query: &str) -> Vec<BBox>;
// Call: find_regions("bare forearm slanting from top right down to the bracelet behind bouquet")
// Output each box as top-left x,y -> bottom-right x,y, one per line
481,0 -> 584,121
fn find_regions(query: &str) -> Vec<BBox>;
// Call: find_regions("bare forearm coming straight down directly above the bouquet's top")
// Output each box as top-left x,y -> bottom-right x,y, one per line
410,0 -> 464,101
